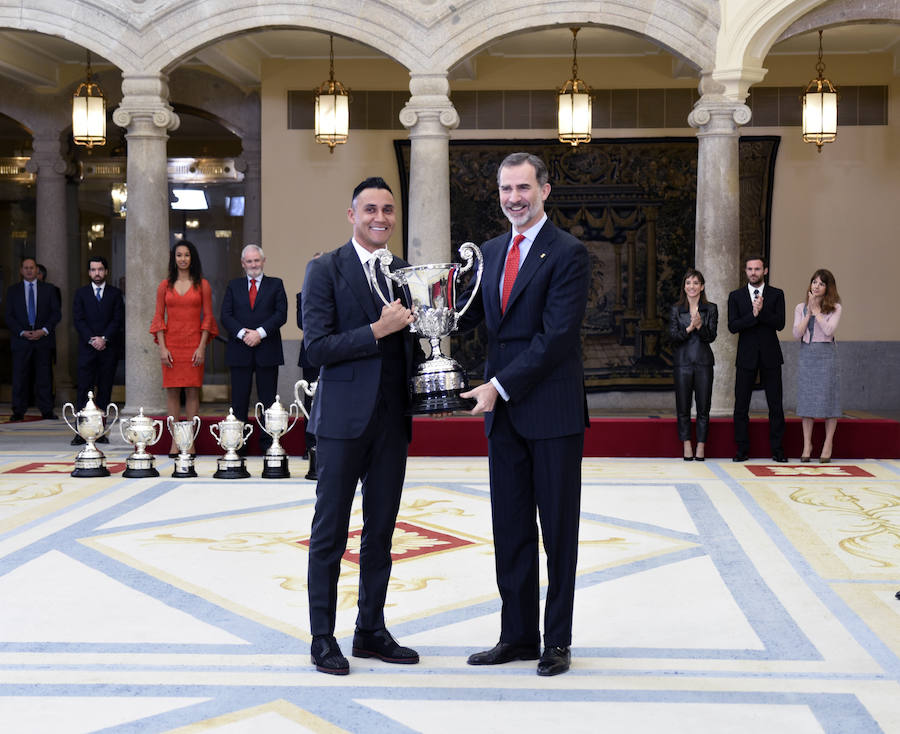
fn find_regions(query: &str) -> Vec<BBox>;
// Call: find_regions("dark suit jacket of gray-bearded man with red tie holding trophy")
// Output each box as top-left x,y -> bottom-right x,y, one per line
460,220 -> 590,439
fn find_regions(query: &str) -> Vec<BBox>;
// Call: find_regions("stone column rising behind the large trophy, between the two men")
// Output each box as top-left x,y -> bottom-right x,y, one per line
400,73 -> 462,264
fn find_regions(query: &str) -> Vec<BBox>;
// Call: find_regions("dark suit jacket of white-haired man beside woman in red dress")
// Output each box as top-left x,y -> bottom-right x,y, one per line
219,275 -> 287,367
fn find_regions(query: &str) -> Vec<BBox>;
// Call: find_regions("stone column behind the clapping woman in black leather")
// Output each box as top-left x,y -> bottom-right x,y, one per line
688,89 -> 751,415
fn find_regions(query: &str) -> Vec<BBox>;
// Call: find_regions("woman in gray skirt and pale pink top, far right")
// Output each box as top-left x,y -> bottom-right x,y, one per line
794,269 -> 841,464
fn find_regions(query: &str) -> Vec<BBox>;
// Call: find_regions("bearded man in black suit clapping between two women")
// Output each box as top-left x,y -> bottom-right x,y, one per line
728,255 -> 787,462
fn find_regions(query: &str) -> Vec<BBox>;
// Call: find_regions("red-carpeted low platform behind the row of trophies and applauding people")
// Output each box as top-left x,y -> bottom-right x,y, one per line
150,416 -> 900,459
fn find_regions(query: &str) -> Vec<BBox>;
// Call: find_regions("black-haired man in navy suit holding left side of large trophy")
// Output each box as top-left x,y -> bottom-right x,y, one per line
303,178 -> 419,675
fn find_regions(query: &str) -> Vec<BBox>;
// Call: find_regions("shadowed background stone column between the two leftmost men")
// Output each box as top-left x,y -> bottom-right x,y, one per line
26,135 -> 74,400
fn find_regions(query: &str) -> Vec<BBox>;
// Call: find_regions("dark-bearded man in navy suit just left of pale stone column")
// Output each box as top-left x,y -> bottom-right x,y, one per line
72,255 -> 125,446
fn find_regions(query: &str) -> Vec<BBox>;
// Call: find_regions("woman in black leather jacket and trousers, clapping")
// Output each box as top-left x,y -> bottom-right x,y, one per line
669,268 -> 719,461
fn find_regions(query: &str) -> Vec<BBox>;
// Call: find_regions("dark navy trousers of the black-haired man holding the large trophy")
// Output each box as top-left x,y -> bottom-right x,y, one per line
308,399 -> 409,635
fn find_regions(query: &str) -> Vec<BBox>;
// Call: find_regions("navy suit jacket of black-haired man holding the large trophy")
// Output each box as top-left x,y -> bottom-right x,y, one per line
302,242 -> 414,440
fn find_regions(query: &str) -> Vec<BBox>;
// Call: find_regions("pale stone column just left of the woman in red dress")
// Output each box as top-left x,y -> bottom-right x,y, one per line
113,73 -> 179,414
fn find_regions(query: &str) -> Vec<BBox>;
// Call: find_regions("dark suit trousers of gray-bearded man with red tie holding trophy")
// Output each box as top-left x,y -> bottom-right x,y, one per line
488,399 -> 584,647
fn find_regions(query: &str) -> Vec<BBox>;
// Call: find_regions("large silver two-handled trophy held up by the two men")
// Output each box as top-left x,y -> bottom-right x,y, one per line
372,242 -> 484,415
